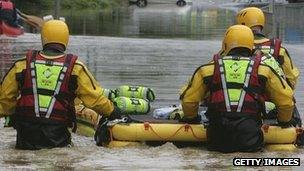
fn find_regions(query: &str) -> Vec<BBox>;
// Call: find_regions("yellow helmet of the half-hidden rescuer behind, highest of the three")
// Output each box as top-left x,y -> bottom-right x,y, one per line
236,7 -> 265,28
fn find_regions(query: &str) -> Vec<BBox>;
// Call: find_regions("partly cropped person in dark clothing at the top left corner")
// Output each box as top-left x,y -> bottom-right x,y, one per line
0,0 -> 19,27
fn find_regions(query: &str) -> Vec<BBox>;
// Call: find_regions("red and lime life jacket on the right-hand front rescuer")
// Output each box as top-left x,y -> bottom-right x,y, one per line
207,54 -> 264,117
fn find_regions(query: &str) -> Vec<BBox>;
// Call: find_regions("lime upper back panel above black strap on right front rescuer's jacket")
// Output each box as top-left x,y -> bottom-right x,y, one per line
223,60 -> 249,84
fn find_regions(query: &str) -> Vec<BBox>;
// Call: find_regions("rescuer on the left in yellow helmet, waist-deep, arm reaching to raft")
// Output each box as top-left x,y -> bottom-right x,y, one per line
0,20 -> 120,150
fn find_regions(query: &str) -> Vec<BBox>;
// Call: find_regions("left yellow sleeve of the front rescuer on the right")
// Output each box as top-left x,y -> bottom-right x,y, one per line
180,64 -> 214,118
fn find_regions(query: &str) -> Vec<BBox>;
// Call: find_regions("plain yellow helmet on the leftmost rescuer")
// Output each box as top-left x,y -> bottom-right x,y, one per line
41,20 -> 69,49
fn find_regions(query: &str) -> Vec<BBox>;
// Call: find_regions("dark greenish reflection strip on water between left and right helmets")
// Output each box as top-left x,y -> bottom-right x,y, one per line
59,4 -> 234,39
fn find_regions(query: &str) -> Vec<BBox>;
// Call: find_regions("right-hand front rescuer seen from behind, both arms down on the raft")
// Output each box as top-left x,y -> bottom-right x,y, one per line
180,25 -> 294,152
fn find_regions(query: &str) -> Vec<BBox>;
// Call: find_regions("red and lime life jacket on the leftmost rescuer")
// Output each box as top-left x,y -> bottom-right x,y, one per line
15,51 -> 77,131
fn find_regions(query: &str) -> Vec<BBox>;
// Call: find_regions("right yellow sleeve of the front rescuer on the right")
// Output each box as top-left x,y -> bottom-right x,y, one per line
258,65 -> 294,122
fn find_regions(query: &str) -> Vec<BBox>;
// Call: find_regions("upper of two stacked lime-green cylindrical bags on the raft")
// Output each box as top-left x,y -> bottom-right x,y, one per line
116,85 -> 155,101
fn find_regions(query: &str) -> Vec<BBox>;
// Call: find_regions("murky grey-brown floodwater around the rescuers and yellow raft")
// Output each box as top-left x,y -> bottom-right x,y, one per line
0,0 -> 304,170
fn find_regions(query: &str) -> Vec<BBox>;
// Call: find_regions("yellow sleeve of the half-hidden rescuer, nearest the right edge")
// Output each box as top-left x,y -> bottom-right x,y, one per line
280,48 -> 300,89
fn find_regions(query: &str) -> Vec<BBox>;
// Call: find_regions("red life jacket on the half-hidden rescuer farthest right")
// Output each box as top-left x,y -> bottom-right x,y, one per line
254,38 -> 284,65
